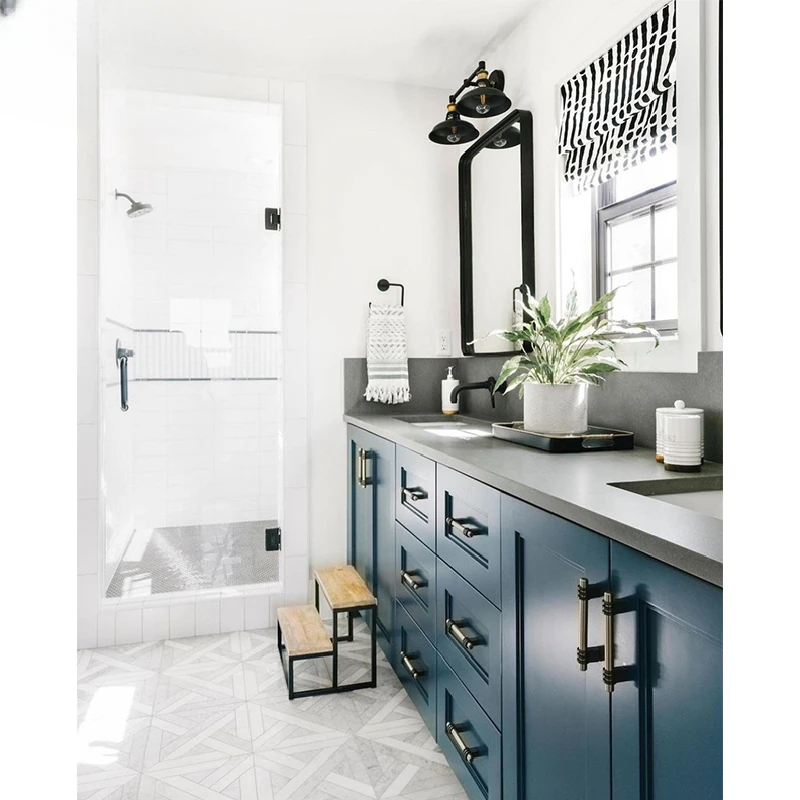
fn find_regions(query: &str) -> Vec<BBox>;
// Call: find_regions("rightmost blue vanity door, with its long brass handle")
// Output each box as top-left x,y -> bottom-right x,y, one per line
610,542 -> 722,800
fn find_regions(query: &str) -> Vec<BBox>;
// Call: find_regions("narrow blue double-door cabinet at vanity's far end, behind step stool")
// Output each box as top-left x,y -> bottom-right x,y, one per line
347,425 -> 395,660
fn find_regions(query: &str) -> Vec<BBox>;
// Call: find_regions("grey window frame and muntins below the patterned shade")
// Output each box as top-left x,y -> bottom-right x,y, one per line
592,178 -> 678,338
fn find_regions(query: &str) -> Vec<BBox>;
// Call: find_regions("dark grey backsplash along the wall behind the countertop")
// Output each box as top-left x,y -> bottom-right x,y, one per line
344,351 -> 722,463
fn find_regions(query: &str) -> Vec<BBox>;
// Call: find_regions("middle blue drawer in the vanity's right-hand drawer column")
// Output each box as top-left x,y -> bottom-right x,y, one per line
436,559 -> 502,728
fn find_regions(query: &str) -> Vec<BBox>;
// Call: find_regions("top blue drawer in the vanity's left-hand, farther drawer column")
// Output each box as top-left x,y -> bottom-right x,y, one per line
395,447 -> 436,550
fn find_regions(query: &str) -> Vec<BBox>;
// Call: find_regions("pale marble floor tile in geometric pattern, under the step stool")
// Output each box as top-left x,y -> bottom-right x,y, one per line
77,621 -> 466,800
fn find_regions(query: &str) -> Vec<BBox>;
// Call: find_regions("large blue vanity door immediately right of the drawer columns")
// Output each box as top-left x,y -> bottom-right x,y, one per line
501,495 -> 618,800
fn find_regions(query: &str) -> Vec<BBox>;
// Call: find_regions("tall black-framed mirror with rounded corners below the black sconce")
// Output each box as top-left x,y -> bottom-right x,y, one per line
458,109 -> 536,356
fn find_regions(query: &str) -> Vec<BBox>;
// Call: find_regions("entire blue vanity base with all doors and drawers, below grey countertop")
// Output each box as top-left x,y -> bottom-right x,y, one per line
348,426 -> 722,800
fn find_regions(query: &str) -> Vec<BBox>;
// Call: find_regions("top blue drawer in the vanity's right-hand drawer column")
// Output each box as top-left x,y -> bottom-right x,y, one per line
436,466 -> 501,608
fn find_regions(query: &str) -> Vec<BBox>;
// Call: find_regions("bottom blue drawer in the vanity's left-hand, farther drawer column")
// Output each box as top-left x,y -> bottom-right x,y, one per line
393,603 -> 437,736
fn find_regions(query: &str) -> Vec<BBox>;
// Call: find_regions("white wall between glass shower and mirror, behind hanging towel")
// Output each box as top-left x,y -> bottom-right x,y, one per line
308,80 -> 463,565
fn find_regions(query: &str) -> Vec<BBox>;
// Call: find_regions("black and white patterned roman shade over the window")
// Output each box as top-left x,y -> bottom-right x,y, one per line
558,0 -> 678,190
